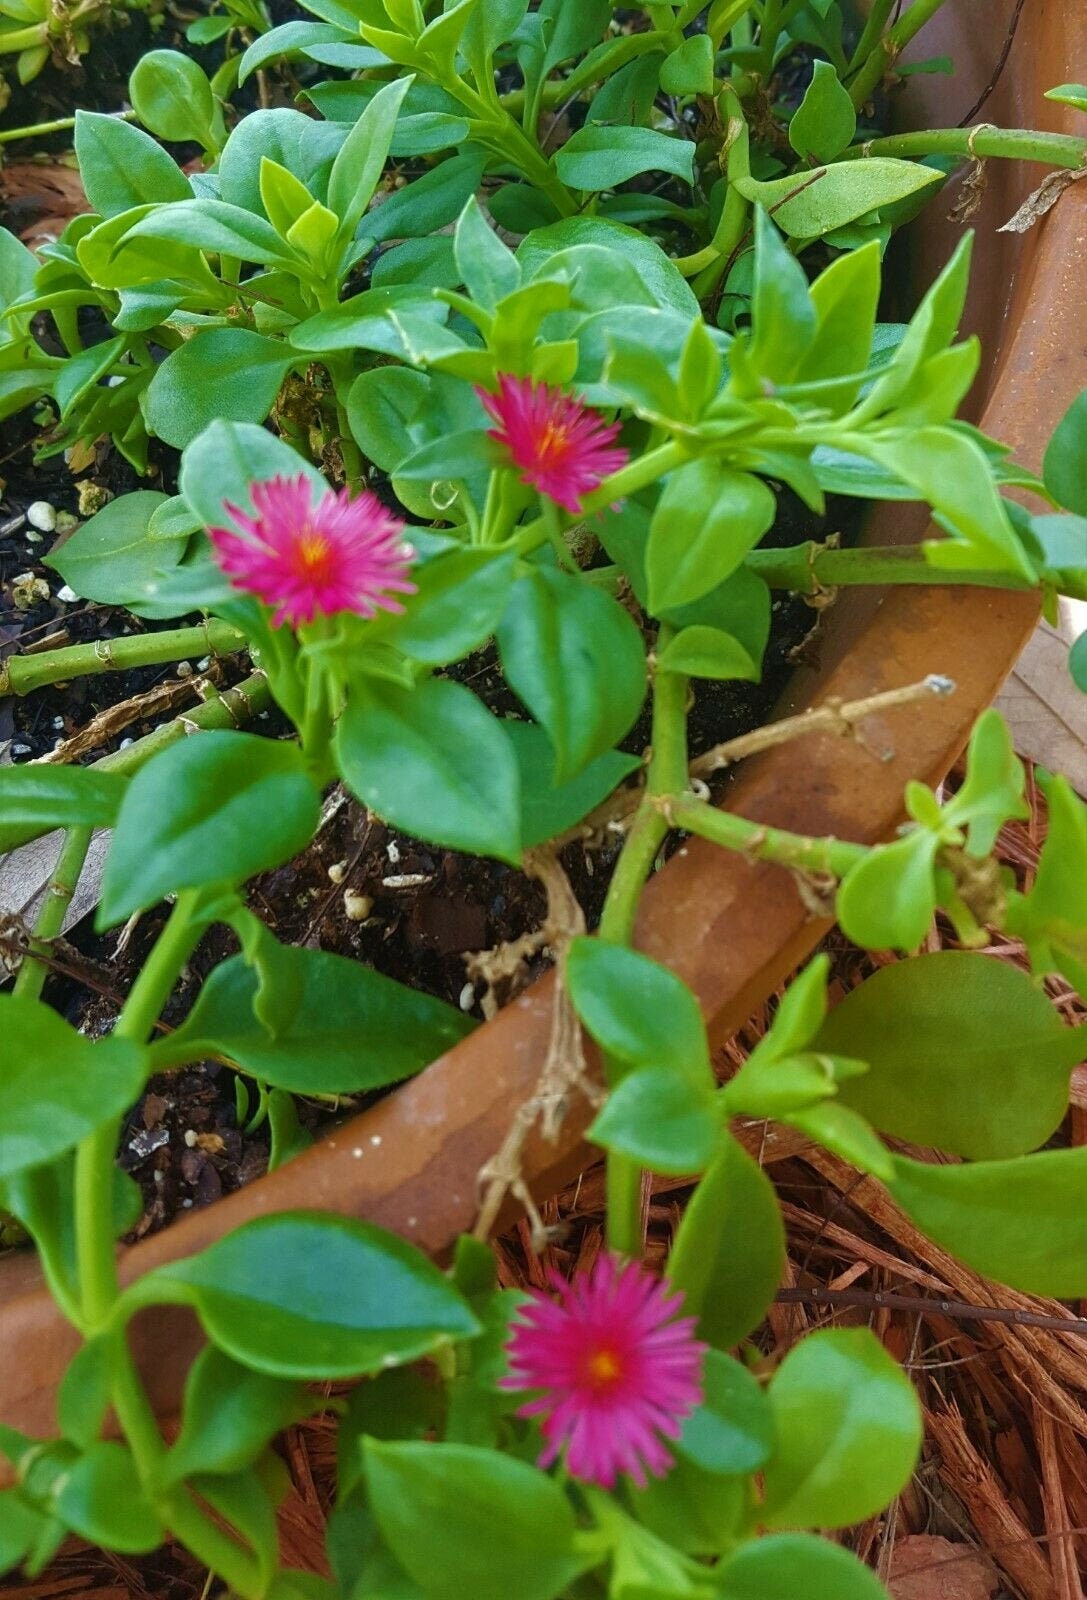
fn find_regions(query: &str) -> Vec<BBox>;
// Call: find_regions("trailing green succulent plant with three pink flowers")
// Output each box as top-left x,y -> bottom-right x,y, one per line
0,0 -> 1087,1600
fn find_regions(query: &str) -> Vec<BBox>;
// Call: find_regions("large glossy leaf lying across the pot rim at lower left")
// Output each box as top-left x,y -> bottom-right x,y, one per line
125,1211 -> 479,1381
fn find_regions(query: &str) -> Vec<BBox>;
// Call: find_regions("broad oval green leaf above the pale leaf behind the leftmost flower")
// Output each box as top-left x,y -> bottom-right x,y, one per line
144,328 -> 298,450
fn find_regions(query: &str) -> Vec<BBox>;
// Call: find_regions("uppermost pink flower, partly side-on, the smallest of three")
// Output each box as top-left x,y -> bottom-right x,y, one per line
475,373 -> 628,517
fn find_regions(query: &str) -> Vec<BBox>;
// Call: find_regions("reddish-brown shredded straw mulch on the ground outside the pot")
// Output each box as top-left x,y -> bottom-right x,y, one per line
0,761 -> 1087,1600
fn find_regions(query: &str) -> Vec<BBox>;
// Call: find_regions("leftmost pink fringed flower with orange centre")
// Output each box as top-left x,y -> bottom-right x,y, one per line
208,474 -> 415,627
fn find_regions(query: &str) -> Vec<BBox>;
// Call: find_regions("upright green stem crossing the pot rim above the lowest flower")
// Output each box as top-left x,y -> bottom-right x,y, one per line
600,622 -> 687,1258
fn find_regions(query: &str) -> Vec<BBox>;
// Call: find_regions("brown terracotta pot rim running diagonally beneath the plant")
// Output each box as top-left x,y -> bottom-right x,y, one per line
0,0 -> 1087,1459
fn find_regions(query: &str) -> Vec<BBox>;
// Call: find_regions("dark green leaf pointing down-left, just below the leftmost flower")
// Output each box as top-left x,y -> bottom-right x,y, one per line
99,733 -> 320,928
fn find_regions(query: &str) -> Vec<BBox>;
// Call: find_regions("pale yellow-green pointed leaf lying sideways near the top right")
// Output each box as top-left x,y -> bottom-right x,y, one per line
736,155 -> 945,238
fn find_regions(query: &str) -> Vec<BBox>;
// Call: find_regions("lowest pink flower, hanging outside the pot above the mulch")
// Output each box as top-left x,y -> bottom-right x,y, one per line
503,1256 -> 706,1490
